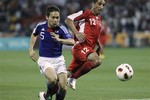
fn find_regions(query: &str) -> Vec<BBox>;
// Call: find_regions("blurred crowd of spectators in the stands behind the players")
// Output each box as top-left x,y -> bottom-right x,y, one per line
0,0 -> 150,37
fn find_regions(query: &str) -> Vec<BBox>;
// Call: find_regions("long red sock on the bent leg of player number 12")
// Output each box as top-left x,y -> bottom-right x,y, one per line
71,61 -> 96,79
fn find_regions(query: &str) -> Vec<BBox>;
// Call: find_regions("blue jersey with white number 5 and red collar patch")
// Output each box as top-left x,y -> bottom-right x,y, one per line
33,21 -> 72,57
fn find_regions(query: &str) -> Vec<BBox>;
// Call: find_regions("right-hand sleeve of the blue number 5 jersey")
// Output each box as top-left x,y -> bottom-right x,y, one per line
60,25 -> 73,39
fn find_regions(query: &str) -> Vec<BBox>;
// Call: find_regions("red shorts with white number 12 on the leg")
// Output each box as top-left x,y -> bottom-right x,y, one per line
68,44 -> 95,72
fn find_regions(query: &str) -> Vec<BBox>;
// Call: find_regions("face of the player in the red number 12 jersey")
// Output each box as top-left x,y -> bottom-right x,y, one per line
93,0 -> 105,15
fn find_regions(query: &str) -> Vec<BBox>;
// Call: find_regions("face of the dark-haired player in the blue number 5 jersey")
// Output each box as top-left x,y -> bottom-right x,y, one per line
46,11 -> 60,28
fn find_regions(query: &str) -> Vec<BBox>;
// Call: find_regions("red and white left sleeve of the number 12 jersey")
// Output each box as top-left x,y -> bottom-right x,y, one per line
67,10 -> 90,21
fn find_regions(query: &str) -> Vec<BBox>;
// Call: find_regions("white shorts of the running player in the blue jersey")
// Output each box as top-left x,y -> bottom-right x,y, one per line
38,55 -> 67,75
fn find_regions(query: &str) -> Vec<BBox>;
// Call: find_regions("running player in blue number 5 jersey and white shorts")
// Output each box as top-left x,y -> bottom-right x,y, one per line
29,6 -> 74,100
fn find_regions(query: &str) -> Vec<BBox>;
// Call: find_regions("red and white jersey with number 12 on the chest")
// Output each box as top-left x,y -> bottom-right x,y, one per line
68,10 -> 101,49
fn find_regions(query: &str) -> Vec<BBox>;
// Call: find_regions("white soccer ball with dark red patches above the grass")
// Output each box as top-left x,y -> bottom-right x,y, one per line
116,63 -> 133,81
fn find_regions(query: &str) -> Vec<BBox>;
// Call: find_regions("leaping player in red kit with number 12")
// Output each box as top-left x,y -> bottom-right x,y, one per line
65,0 -> 105,89
